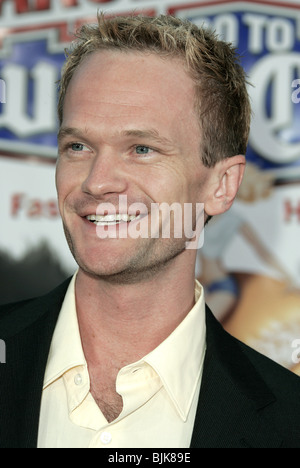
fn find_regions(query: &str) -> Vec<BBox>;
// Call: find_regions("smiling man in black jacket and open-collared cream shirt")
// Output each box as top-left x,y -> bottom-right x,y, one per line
0,16 -> 300,448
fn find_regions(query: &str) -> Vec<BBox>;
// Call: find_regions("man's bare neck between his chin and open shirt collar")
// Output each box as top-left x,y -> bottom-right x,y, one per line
76,262 -> 195,365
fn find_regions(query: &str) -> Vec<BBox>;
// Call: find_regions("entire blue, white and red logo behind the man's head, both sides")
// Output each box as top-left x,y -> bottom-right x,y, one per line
0,0 -> 300,169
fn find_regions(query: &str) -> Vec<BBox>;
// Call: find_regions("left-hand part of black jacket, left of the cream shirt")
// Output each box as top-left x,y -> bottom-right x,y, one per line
0,280 -> 69,448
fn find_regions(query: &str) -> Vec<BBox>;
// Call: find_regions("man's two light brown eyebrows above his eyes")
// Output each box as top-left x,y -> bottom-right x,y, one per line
57,127 -> 173,146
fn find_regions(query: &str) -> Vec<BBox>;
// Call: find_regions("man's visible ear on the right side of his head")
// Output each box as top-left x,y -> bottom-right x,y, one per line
205,155 -> 246,216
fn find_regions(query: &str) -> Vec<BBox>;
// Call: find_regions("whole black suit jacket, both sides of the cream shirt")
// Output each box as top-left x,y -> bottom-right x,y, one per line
0,281 -> 300,448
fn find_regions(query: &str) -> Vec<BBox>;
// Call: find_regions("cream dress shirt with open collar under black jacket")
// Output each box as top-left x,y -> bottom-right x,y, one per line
38,275 -> 206,448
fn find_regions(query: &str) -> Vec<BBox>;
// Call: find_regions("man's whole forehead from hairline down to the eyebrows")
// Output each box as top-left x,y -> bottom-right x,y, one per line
63,50 -> 199,148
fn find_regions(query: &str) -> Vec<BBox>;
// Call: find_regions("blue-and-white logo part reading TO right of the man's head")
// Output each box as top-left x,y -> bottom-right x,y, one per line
169,1 -> 300,169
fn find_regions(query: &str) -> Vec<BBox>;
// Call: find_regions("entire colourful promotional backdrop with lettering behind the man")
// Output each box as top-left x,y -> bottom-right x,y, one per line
0,0 -> 300,374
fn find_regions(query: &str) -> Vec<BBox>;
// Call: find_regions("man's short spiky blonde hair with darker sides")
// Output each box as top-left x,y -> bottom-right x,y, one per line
58,14 -> 251,167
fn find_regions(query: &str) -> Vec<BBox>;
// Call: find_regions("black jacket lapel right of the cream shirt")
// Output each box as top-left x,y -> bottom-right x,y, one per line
191,309 -> 282,448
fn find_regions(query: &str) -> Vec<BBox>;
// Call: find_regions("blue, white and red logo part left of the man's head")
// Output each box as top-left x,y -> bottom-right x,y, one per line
0,0 -> 156,158
